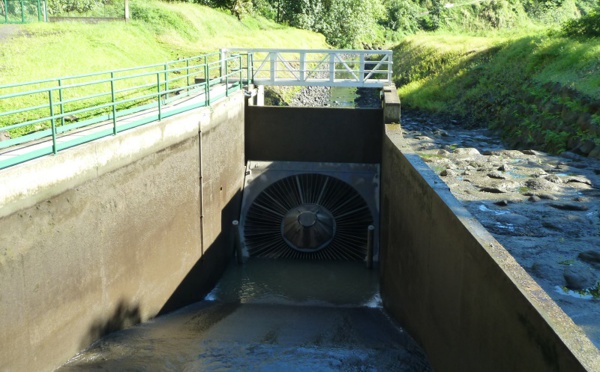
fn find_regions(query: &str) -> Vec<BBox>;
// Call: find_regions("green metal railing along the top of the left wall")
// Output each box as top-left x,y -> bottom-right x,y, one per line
0,53 -> 252,169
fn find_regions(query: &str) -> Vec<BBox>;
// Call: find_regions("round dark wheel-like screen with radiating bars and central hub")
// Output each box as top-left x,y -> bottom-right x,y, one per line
244,174 -> 373,260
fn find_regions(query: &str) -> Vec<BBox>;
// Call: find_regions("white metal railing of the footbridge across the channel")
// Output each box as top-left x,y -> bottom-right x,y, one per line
221,48 -> 392,88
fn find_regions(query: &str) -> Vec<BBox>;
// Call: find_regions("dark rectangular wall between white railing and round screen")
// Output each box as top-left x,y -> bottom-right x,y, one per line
246,106 -> 383,163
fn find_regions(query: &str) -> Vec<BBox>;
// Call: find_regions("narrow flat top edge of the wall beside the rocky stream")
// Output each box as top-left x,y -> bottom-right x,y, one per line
385,125 -> 600,371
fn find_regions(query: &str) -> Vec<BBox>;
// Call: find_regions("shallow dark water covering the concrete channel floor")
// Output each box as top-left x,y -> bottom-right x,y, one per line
60,260 -> 430,371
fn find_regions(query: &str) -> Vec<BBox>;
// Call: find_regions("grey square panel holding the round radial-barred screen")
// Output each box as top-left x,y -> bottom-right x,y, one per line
242,163 -> 378,261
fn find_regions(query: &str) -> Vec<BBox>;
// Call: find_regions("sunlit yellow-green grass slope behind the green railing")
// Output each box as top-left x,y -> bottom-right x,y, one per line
0,0 -> 327,85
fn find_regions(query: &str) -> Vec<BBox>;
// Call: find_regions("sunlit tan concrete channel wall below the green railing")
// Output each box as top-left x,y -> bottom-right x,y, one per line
0,92 -> 244,371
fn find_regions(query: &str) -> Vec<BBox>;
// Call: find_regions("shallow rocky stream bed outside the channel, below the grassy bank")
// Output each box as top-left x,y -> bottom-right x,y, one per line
402,112 -> 600,348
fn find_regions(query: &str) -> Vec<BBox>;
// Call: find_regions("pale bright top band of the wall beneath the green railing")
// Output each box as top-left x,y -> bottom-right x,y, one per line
0,107 -> 211,218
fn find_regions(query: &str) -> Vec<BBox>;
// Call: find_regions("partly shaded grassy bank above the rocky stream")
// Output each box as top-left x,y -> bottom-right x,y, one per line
394,31 -> 600,158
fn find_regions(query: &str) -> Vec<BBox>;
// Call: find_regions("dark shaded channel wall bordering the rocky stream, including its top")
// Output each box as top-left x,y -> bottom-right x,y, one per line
380,125 -> 600,372
